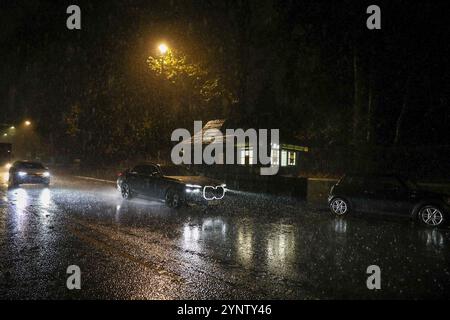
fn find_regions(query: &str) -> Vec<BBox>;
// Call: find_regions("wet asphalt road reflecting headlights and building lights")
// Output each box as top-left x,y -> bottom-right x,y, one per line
0,171 -> 450,299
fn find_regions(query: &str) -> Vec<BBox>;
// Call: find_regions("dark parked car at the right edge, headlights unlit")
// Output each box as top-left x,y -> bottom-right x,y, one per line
328,174 -> 450,227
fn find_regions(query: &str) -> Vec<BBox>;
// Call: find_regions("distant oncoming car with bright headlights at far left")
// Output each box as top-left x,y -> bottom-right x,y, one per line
8,160 -> 50,187
